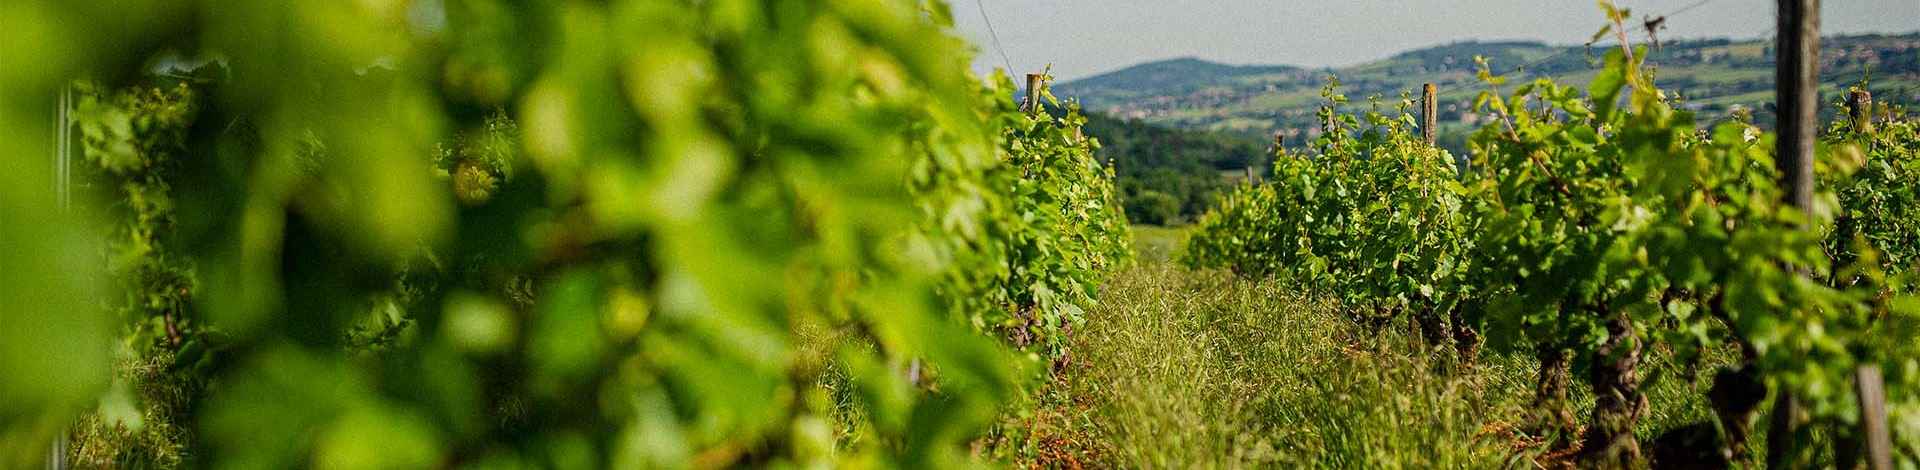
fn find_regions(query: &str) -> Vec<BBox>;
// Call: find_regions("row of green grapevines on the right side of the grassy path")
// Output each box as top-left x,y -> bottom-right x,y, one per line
1187,32 -> 1920,464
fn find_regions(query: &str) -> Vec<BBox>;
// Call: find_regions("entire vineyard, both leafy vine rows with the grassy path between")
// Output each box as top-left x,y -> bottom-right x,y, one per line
0,0 -> 1920,468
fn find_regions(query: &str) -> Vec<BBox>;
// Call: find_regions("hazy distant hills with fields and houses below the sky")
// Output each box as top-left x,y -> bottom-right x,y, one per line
1054,33 -> 1920,142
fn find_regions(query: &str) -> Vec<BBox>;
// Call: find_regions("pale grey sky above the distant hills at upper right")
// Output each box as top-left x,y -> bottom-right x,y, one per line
948,0 -> 1920,81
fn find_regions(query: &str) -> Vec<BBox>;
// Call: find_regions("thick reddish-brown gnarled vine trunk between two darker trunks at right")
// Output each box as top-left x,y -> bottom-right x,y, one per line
1580,313 -> 1647,468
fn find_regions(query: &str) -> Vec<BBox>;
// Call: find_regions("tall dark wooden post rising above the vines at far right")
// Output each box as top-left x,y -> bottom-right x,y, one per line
1766,0 -> 1820,468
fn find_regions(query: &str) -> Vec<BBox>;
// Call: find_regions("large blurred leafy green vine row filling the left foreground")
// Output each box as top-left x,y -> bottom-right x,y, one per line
0,0 -> 1127,468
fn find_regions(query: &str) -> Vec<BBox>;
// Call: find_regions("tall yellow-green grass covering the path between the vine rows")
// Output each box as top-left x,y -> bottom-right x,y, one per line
998,226 -> 1759,468
